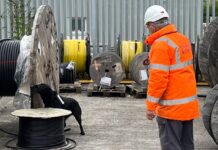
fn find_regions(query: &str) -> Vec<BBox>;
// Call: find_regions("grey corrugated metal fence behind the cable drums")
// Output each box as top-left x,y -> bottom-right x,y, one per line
0,0 -> 215,53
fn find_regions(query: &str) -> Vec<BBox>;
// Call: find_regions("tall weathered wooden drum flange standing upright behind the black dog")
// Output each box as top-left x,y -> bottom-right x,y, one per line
30,5 -> 59,108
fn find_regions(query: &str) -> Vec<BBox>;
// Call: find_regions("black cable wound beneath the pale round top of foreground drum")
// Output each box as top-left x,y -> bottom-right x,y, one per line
17,117 -> 66,149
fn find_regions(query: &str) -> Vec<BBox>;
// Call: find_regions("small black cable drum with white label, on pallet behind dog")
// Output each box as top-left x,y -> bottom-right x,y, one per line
59,62 -> 76,83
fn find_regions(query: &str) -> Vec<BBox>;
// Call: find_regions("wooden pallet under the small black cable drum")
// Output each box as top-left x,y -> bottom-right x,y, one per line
59,81 -> 82,93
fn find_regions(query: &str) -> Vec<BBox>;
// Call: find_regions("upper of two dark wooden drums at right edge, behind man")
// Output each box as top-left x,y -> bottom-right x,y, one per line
198,18 -> 218,87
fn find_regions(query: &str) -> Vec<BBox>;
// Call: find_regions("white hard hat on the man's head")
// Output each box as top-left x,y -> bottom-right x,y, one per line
144,5 -> 169,25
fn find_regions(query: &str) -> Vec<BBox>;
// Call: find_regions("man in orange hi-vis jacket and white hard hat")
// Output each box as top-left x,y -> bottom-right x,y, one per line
144,5 -> 199,150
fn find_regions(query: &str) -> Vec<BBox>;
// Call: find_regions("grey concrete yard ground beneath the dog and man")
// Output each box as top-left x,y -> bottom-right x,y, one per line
0,87 -> 218,150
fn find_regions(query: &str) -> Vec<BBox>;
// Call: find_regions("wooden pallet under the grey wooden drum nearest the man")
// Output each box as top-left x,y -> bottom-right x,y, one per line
126,83 -> 147,98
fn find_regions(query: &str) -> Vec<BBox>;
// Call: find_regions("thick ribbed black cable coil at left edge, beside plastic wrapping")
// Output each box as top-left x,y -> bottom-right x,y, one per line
0,39 -> 20,96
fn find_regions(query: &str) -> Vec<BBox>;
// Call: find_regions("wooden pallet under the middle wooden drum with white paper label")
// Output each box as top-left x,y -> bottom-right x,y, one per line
87,83 -> 126,97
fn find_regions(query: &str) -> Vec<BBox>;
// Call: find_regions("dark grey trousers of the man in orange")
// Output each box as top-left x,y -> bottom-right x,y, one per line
157,117 -> 194,150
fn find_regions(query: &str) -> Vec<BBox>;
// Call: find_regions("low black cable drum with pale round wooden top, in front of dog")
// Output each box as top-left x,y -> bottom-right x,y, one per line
12,108 -> 72,149
